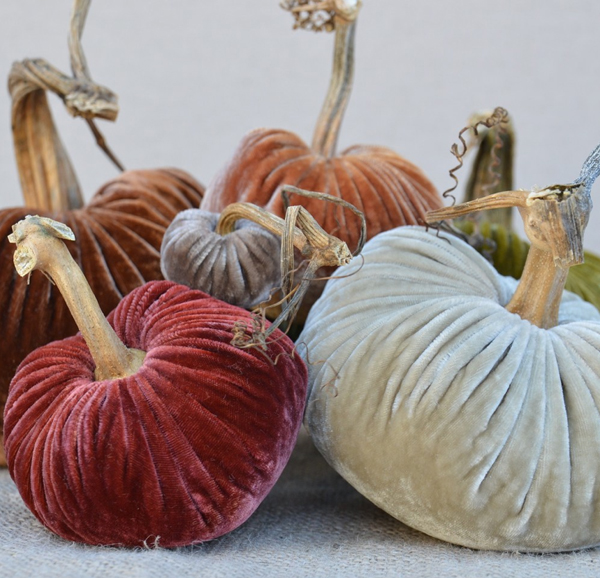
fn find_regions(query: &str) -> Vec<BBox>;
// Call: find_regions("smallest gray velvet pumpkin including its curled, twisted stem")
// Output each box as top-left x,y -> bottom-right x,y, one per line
161,185 -> 366,321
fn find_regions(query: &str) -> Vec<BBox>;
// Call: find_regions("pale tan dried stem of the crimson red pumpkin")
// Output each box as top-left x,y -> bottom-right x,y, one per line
9,216 -> 146,380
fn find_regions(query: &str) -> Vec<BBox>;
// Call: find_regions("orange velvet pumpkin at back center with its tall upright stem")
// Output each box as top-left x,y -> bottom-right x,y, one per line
202,0 -> 441,254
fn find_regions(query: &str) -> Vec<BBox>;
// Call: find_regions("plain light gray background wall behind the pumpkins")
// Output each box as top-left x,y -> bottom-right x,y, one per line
0,0 -> 600,246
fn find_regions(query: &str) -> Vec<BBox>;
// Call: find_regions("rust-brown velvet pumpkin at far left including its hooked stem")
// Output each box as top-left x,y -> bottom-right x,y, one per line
0,2 -> 203,464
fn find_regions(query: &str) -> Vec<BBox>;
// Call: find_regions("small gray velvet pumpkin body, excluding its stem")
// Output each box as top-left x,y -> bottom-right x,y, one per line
161,209 -> 281,309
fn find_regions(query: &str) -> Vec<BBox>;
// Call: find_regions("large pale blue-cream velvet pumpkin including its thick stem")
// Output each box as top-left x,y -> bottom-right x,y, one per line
300,140 -> 600,552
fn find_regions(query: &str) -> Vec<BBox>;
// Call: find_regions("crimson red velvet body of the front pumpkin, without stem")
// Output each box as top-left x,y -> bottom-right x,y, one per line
5,281 -> 307,547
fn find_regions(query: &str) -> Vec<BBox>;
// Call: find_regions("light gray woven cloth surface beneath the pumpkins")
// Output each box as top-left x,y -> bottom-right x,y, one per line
0,432 -> 600,578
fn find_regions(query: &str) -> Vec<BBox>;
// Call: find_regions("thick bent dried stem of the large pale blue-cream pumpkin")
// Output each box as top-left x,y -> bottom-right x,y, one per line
426,183 -> 591,328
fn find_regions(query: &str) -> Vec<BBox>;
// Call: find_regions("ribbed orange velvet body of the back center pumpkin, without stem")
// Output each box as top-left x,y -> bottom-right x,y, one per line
201,129 -> 442,249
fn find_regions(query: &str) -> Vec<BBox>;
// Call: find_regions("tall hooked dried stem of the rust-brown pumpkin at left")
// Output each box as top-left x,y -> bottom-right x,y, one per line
8,0 -> 122,211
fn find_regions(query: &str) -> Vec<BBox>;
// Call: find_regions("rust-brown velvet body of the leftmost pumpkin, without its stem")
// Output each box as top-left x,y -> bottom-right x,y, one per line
0,169 -> 203,464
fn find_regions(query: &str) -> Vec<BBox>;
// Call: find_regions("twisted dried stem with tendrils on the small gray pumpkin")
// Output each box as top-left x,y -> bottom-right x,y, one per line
216,187 -> 366,350
